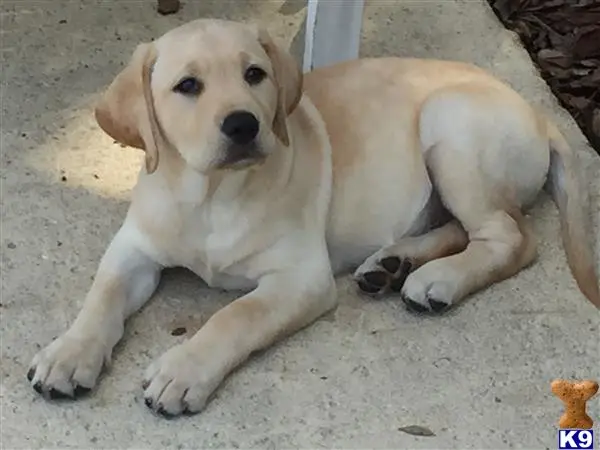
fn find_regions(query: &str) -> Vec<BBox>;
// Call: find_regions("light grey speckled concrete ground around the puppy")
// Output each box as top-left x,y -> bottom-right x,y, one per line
0,0 -> 600,449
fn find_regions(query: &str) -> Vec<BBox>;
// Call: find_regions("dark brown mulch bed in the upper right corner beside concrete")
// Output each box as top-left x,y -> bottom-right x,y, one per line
488,0 -> 600,153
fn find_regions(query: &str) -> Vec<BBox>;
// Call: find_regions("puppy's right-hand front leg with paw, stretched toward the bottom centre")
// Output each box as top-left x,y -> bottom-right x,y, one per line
144,264 -> 336,417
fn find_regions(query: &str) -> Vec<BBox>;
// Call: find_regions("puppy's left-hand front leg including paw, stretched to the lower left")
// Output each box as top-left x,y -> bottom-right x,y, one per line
27,222 -> 161,398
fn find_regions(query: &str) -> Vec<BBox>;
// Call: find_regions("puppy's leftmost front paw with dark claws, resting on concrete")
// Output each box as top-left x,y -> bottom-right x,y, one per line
27,333 -> 111,399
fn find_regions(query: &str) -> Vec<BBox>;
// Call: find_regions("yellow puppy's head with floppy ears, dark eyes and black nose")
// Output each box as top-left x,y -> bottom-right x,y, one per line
96,20 -> 302,173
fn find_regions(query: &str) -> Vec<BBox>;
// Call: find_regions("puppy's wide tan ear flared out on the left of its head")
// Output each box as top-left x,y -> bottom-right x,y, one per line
95,43 -> 162,174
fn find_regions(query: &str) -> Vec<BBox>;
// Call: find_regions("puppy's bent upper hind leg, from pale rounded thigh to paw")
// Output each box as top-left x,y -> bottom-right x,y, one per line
394,84 -> 550,312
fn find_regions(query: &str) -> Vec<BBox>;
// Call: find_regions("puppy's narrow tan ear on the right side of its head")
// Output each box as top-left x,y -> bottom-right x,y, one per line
258,29 -> 302,146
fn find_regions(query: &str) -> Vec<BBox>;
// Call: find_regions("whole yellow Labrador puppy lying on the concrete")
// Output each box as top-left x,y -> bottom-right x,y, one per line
28,20 -> 600,416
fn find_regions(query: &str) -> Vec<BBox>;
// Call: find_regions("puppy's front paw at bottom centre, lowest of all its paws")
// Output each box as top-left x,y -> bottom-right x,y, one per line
143,342 -> 222,417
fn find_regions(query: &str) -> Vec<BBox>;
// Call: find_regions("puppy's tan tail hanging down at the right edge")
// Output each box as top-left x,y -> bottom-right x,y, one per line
547,120 -> 600,309
